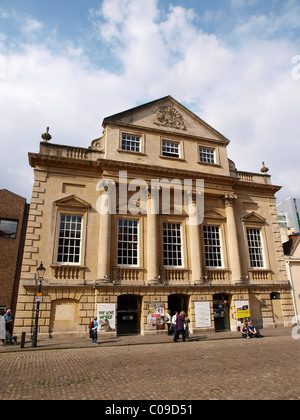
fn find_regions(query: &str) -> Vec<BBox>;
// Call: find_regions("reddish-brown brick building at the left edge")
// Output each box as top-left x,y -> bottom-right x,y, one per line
0,189 -> 29,312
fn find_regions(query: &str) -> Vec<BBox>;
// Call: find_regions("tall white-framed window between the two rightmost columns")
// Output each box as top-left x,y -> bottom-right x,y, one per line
203,225 -> 224,269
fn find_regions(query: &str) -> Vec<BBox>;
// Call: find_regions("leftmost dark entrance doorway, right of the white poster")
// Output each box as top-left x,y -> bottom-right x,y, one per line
117,295 -> 142,335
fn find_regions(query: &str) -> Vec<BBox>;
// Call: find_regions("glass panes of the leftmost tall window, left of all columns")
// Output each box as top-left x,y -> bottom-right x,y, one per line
57,214 -> 82,264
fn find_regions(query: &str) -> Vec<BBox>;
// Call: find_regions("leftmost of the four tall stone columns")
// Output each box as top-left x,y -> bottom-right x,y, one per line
98,190 -> 111,283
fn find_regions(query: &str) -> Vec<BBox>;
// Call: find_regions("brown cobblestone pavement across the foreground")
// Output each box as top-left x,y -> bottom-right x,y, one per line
0,335 -> 300,402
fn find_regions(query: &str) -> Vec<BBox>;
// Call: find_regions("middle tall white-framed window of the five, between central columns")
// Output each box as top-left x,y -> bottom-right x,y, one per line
163,222 -> 184,268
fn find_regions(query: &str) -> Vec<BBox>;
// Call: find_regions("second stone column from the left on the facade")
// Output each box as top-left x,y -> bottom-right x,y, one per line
147,187 -> 160,285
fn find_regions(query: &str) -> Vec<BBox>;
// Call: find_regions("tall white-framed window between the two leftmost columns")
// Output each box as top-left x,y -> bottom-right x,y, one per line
117,218 -> 140,267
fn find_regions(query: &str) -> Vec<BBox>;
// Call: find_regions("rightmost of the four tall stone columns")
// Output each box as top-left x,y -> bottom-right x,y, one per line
223,194 -> 244,284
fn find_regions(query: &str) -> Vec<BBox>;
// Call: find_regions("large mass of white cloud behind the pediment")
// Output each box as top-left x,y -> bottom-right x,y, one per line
0,0 -> 300,203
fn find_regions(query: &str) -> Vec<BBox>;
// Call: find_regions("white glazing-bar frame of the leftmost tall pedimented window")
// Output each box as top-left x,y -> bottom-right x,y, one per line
56,212 -> 84,265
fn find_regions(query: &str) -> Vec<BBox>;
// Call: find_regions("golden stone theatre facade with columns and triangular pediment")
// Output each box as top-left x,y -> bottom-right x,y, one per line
15,96 -> 294,335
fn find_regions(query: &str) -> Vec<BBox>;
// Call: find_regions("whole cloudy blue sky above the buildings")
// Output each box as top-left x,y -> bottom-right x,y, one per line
0,0 -> 300,201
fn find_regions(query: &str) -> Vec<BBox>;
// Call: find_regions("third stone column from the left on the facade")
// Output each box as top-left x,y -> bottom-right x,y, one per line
188,193 -> 205,285
